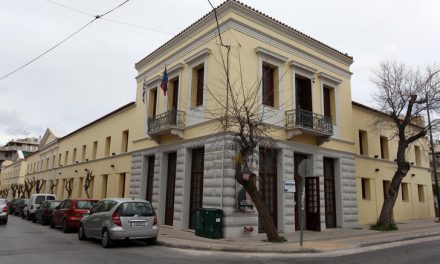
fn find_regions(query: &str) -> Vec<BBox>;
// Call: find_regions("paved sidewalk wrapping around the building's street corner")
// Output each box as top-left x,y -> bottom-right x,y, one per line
158,219 -> 440,253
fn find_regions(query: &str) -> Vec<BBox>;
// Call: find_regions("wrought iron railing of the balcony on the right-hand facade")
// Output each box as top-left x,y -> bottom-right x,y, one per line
286,109 -> 333,136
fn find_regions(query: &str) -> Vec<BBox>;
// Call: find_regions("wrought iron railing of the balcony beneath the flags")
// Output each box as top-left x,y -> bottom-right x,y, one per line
148,110 -> 186,134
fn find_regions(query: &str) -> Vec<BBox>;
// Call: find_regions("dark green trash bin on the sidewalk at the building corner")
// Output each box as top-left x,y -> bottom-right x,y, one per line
196,208 -> 223,239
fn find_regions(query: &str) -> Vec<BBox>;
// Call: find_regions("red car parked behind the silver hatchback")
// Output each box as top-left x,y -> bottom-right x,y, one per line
50,199 -> 97,233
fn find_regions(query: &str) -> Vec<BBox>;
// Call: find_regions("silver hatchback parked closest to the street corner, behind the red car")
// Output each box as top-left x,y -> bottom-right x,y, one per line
78,198 -> 159,248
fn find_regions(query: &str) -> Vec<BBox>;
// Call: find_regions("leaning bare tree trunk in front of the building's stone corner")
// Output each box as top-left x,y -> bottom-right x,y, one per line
235,159 -> 280,241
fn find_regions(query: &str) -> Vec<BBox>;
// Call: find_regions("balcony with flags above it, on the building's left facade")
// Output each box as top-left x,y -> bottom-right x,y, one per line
148,110 -> 186,138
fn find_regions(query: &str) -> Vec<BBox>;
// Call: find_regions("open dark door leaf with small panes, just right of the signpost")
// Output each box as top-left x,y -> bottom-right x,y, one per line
305,177 -> 321,231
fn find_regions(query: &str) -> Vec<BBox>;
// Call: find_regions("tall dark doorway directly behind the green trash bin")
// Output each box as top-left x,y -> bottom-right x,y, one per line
189,148 -> 205,229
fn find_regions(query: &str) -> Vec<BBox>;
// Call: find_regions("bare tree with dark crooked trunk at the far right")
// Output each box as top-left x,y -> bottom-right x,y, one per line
373,62 -> 440,229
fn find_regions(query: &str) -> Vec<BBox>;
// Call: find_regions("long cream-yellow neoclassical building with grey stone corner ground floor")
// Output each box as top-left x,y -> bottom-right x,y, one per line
0,0 -> 433,237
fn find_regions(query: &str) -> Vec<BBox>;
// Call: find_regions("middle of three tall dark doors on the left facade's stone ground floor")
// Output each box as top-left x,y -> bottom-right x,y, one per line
165,153 -> 176,226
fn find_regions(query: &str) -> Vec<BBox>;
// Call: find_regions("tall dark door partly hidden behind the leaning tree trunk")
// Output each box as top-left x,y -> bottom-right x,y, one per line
258,148 -> 277,233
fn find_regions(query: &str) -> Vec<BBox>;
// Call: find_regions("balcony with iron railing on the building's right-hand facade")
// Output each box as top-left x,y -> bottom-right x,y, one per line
286,109 -> 333,144
